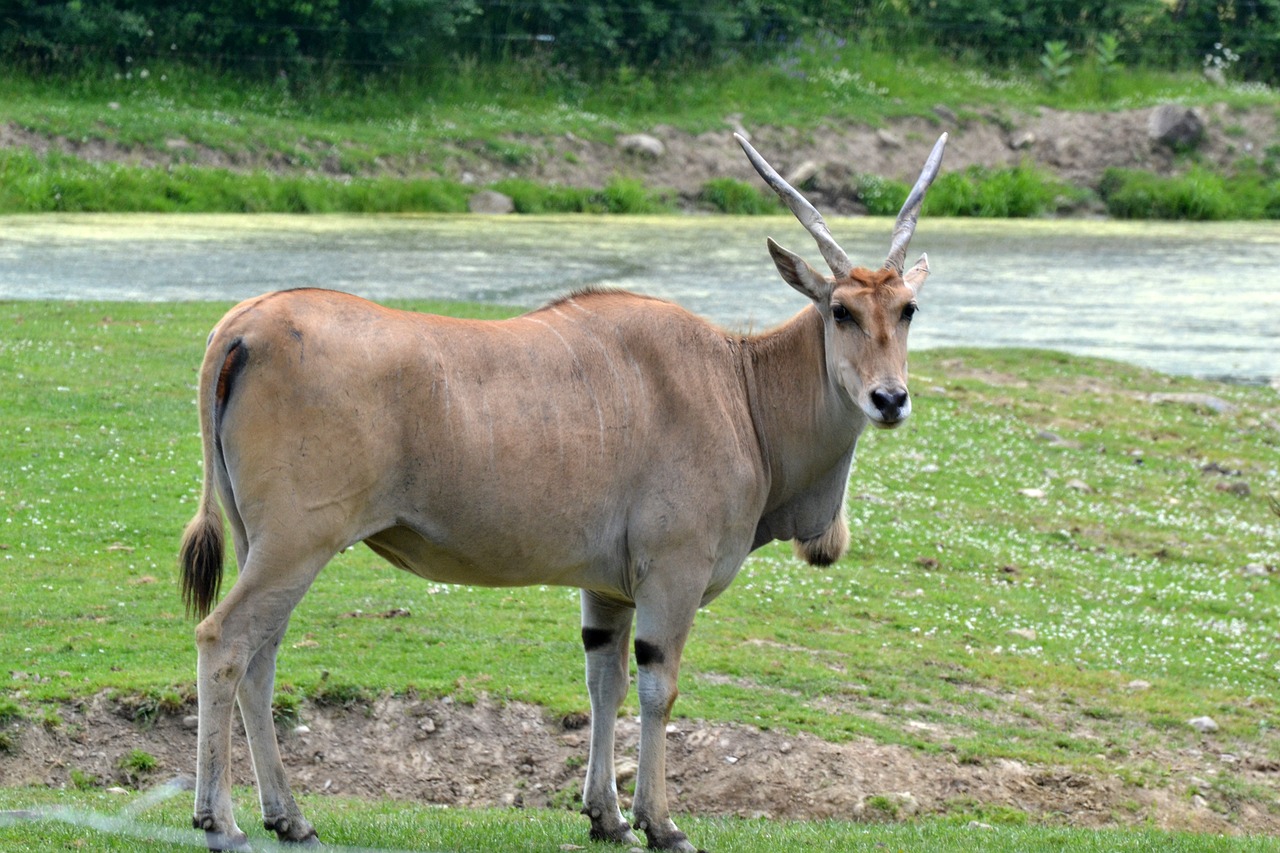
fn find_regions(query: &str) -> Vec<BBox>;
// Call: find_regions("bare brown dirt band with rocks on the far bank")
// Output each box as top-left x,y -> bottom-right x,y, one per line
0,104 -> 1280,213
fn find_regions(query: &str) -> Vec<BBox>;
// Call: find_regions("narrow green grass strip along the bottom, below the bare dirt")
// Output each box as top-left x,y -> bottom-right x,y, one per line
0,789 -> 1280,853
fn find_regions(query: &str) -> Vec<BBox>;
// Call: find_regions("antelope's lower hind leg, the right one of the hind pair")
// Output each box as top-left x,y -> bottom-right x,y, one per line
236,624 -> 319,844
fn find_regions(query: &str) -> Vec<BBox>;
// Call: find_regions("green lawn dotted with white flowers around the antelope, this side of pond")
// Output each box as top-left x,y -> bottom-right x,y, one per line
0,302 -> 1280,850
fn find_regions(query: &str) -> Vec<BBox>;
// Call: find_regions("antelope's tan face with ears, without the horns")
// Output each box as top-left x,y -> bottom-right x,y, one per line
769,241 -> 929,429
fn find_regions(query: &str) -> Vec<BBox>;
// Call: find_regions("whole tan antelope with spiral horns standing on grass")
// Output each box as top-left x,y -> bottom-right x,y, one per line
182,134 -> 946,852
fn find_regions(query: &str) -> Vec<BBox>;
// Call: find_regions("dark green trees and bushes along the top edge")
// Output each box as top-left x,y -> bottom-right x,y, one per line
0,0 -> 1280,83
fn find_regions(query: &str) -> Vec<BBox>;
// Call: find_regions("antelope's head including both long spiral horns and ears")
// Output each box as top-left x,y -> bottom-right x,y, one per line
733,133 -> 947,429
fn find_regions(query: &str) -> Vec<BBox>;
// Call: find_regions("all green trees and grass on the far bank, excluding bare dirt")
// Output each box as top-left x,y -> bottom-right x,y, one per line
0,0 -> 1280,219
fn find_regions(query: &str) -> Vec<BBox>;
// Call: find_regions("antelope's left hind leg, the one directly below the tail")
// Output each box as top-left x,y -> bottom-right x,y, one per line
192,547 -> 332,849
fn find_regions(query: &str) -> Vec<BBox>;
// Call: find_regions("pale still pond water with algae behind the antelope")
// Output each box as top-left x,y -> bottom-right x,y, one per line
0,215 -> 1280,382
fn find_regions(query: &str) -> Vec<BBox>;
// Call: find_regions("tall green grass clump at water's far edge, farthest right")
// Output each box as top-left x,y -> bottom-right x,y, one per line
1098,167 -> 1280,222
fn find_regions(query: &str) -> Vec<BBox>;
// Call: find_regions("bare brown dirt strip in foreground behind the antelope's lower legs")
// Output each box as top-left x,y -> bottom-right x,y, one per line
0,695 -> 1280,834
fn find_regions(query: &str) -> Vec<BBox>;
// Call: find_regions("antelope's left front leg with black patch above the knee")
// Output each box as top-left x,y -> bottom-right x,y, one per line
582,589 -> 640,844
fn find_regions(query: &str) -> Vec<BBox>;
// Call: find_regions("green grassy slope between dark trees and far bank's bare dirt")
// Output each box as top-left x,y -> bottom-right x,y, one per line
0,40 -> 1276,155
